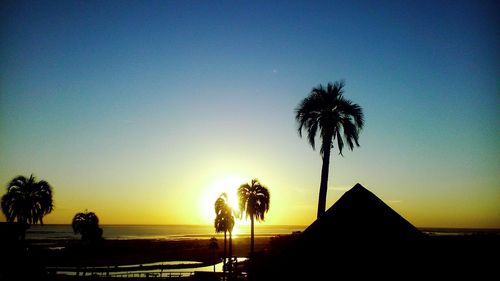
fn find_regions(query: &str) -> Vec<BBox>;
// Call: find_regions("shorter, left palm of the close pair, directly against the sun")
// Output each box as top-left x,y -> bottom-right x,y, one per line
214,192 -> 234,270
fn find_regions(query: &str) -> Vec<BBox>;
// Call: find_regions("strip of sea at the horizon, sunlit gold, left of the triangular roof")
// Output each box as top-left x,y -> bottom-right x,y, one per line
26,224 -> 306,239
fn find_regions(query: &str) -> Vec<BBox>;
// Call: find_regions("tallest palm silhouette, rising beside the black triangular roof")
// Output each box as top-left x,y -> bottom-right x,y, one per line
295,81 -> 364,218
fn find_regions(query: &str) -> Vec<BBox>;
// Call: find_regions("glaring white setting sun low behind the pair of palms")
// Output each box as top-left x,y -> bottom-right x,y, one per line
199,175 -> 247,224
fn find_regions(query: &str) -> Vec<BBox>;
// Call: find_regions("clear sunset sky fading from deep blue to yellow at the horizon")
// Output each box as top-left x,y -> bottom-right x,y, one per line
0,1 -> 500,228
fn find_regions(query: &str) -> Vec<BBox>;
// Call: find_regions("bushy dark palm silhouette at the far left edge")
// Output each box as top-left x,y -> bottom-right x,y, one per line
1,174 -> 54,237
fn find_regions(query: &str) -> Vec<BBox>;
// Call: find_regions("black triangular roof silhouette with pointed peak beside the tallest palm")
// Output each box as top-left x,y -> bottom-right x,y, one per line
303,183 -> 422,240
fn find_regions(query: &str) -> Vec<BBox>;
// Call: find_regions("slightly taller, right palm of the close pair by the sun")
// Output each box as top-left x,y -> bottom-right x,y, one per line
238,179 -> 271,256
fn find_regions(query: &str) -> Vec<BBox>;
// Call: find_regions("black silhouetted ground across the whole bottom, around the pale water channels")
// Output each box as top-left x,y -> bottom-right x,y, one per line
0,233 -> 500,281
